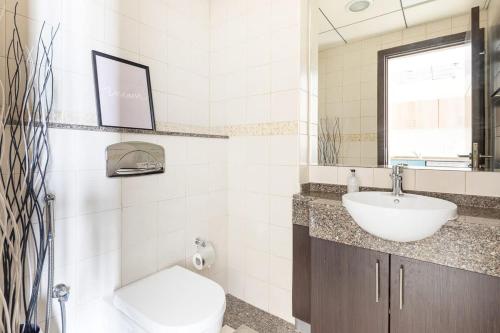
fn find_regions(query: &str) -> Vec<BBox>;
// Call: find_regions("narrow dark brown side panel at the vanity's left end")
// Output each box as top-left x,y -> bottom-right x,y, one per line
292,225 -> 311,323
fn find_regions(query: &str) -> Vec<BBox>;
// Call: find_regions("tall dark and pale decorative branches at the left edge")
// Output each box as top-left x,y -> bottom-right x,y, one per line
0,4 -> 59,333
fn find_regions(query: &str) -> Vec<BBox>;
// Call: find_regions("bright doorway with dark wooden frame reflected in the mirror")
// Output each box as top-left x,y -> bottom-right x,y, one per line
378,33 -> 472,168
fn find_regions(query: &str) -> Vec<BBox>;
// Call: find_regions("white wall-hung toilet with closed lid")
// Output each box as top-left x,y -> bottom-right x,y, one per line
113,266 -> 226,333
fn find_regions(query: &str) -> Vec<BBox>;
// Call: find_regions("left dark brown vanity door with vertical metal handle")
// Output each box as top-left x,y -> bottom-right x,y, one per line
311,238 -> 389,333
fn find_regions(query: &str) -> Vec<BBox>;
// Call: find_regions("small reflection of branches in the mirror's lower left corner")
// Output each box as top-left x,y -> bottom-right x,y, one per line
318,116 -> 342,165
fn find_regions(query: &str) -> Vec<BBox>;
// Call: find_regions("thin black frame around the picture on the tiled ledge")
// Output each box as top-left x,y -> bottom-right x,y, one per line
91,50 -> 156,131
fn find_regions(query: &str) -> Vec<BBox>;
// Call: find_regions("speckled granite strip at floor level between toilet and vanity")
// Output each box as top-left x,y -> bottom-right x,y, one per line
224,294 -> 296,333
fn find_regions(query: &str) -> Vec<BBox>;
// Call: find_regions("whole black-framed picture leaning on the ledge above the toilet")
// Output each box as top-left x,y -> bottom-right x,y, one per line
92,51 -> 155,130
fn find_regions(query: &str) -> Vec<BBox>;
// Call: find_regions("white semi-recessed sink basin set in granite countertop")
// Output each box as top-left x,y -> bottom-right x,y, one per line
342,192 -> 457,242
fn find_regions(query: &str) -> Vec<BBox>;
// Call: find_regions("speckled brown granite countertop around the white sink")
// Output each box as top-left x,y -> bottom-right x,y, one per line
293,187 -> 500,277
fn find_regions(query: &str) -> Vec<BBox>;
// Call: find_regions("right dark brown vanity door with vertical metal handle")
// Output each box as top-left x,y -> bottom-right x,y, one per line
390,256 -> 500,333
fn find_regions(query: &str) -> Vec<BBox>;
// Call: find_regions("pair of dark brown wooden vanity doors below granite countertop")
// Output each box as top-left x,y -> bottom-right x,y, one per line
306,238 -> 500,333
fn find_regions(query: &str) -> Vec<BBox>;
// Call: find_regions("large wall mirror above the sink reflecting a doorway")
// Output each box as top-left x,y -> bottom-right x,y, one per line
310,0 -> 500,170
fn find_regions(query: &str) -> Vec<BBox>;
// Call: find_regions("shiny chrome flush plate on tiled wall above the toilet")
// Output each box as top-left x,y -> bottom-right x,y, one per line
106,141 -> 165,177
